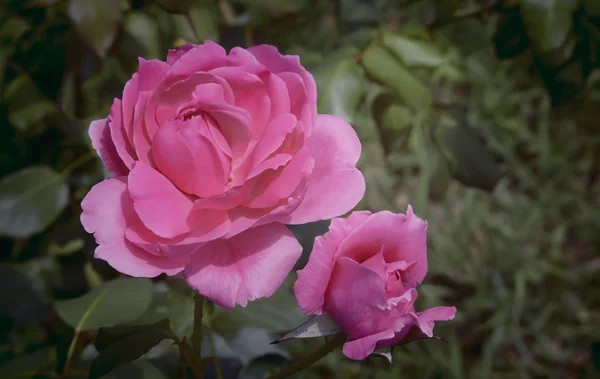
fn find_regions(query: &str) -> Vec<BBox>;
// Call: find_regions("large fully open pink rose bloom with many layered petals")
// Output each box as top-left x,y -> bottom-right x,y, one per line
81,42 -> 365,308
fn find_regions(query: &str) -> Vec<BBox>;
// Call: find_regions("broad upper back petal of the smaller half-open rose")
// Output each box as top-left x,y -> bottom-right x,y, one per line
339,208 -> 427,287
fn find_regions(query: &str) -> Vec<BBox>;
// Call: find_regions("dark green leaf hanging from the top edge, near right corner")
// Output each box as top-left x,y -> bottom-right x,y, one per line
520,0 -> 579,53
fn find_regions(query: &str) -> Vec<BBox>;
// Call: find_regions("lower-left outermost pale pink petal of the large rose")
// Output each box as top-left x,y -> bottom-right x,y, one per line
81,176 -> 188,277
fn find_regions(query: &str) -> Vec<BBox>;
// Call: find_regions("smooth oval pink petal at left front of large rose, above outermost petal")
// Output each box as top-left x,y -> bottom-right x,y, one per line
128,162 -> 194,238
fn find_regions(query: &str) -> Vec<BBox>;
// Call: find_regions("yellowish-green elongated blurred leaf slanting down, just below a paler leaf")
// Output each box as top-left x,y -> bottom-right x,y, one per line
362,46 -> 433,110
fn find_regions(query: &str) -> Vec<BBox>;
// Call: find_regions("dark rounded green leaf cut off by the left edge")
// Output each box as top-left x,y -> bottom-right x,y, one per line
0,166 -> 69,238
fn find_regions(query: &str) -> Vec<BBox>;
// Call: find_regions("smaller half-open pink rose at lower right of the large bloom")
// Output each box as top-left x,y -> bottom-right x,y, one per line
294,206 -> 456,360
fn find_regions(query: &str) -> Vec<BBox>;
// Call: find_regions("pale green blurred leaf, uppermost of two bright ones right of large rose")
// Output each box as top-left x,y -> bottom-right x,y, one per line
383,33 -> 446,68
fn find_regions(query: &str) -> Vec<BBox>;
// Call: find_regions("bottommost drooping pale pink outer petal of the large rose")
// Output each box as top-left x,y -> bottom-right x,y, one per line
181,223 -> 302,309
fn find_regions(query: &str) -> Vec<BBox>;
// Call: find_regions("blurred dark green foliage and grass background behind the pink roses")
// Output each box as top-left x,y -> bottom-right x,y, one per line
0,0 -> 600,379
